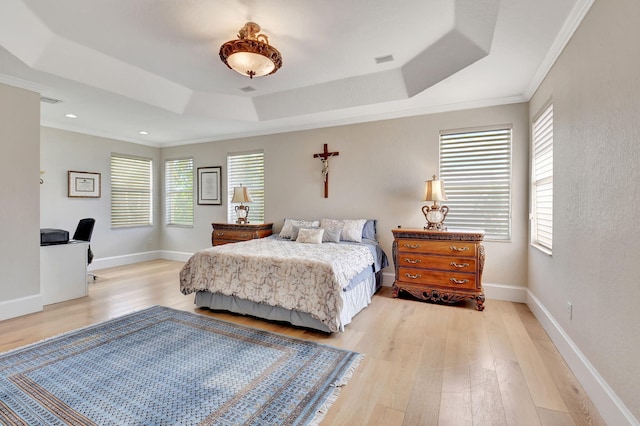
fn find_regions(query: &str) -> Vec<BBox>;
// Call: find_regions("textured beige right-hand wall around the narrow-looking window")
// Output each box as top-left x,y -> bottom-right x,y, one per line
529,0 -> 640,424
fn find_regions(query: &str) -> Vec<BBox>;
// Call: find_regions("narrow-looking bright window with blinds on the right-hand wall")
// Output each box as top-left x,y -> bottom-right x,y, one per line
531,104 -> 553,252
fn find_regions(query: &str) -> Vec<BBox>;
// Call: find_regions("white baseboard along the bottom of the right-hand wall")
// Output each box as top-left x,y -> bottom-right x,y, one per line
526,289 -> 640,426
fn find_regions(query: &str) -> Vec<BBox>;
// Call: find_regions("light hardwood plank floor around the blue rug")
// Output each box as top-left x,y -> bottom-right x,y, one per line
0,260 -> 604,426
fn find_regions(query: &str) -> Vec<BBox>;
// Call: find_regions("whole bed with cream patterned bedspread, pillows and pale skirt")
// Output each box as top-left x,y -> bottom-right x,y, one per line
180,219 -> 388,333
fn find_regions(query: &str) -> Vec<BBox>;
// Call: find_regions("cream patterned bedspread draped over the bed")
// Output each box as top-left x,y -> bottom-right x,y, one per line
180,238 -> 374,332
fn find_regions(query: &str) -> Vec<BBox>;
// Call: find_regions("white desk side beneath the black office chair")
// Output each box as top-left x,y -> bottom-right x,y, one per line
40,241 -> 89,305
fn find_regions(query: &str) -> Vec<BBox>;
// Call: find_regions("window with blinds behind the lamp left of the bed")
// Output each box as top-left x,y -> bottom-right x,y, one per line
227,151 -> 264,223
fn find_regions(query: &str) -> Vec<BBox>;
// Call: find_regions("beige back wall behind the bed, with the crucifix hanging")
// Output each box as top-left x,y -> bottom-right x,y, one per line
162,104 -> 529,286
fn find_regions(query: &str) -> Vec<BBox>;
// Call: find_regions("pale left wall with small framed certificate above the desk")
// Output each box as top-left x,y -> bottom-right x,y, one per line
40,127 -> 162,267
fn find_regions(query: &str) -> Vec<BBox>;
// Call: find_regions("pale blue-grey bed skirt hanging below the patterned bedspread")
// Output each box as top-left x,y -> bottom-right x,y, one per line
195,272 -> 382,333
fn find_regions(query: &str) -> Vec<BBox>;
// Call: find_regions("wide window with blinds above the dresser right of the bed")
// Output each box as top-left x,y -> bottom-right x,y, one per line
440,128 -> 511,241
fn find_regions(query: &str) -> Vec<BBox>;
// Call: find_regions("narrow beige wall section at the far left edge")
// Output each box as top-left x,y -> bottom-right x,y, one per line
0,84 -> 40,310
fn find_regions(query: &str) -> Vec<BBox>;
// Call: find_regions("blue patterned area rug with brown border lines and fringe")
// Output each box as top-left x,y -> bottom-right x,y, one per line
0,306 -> 362,425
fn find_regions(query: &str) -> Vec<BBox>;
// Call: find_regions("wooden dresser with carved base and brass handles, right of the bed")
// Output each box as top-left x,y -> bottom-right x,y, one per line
392,228 -> 485,311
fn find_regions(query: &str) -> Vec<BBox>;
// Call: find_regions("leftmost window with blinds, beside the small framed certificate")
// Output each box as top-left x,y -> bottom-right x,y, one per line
111,154 -> 152,228
